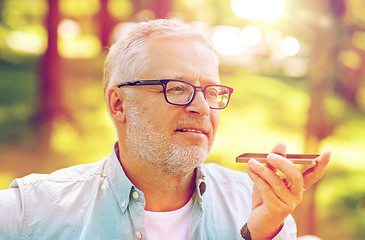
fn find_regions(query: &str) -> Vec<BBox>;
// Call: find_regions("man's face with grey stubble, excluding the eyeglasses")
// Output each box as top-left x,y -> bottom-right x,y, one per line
126,38 -> 220,173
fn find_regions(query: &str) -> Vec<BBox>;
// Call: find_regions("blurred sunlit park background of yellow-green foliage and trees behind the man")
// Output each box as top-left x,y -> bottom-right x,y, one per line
0,0 -> 365,240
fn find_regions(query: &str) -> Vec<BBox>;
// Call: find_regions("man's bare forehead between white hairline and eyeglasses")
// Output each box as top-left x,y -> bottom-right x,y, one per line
143,37 -> 219,84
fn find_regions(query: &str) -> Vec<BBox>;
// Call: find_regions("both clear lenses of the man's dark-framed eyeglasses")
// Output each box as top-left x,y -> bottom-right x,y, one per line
165,81 -> 229,108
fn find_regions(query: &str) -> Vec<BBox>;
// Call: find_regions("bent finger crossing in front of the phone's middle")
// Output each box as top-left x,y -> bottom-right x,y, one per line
267,153 -> 304,198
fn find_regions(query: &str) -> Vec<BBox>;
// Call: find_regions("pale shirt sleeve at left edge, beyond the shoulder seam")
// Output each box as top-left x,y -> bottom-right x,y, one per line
0,188 -> 24,239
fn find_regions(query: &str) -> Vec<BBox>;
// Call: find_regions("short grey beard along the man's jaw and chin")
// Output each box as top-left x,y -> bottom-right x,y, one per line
126,103 -> 209,174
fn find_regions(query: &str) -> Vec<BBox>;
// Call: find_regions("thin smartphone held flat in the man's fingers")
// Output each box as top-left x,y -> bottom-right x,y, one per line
236,153 -> 319,164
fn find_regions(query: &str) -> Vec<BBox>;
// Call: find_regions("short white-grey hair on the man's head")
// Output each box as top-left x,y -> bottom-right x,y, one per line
104,19 -> 218,100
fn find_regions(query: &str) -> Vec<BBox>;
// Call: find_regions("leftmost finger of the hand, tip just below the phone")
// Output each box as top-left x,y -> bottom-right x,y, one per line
248,159 -> 292,203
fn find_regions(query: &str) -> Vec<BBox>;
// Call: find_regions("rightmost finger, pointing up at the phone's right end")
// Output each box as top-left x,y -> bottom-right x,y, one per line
303,151 -> 331,189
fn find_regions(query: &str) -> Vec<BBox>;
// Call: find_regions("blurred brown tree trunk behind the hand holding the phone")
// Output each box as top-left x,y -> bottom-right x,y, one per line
294,10 -> 335,239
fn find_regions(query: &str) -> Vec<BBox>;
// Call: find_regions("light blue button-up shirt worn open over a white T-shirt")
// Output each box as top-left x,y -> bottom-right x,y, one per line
0,145 -> 296,240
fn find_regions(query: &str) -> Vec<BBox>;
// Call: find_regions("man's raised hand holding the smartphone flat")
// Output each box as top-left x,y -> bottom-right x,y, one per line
247,143 -> 331,240
